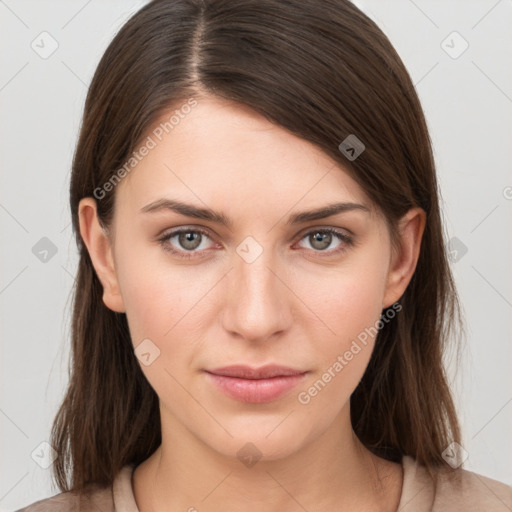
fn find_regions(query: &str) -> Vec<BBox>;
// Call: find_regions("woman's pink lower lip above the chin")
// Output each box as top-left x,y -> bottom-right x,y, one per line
206,372 -> 306,404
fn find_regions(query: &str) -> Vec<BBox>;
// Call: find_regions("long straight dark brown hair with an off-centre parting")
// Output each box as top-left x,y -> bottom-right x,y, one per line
51,0 -> 461,493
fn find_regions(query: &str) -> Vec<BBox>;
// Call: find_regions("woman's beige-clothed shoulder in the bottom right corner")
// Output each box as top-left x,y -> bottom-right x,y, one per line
399,457 -> 512,512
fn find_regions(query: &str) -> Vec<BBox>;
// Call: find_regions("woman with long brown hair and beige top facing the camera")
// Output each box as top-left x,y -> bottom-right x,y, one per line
16,0 -> 512,512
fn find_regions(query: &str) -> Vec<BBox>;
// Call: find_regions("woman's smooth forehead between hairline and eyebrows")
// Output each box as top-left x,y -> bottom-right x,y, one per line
116,97 -> 370,214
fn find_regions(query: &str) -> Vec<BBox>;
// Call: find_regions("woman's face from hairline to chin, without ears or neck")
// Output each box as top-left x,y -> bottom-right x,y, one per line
83,97 -> 422,459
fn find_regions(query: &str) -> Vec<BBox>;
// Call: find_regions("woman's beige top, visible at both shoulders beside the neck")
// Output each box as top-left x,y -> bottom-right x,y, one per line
16,456 -> 512,512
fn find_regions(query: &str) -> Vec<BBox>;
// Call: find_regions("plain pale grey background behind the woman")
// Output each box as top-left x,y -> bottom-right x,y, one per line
0,0 -> 512,506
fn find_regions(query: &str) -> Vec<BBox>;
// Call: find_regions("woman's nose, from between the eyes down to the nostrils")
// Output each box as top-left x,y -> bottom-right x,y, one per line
225,237 -> 290,339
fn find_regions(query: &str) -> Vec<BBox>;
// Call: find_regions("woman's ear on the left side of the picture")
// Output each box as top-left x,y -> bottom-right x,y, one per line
78,197 -> 125,313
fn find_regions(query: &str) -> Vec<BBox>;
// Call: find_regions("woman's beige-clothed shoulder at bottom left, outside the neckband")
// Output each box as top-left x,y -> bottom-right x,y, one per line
15,485 -> 115,512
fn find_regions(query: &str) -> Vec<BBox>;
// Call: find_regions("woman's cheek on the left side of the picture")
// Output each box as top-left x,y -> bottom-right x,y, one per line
115,254 -> 211,408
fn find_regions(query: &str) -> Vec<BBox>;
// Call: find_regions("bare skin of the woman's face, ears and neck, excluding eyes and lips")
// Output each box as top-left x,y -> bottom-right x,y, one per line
79,96 -> 425,512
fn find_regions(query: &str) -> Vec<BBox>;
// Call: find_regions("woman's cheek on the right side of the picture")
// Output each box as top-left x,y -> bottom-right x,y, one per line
292,253 -> 385,404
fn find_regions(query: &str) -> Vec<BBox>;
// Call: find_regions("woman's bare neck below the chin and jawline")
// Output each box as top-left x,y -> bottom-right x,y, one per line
133,407 -> 402,512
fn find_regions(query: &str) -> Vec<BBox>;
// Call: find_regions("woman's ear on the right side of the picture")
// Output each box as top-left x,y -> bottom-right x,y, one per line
382,208 -> 426,308
